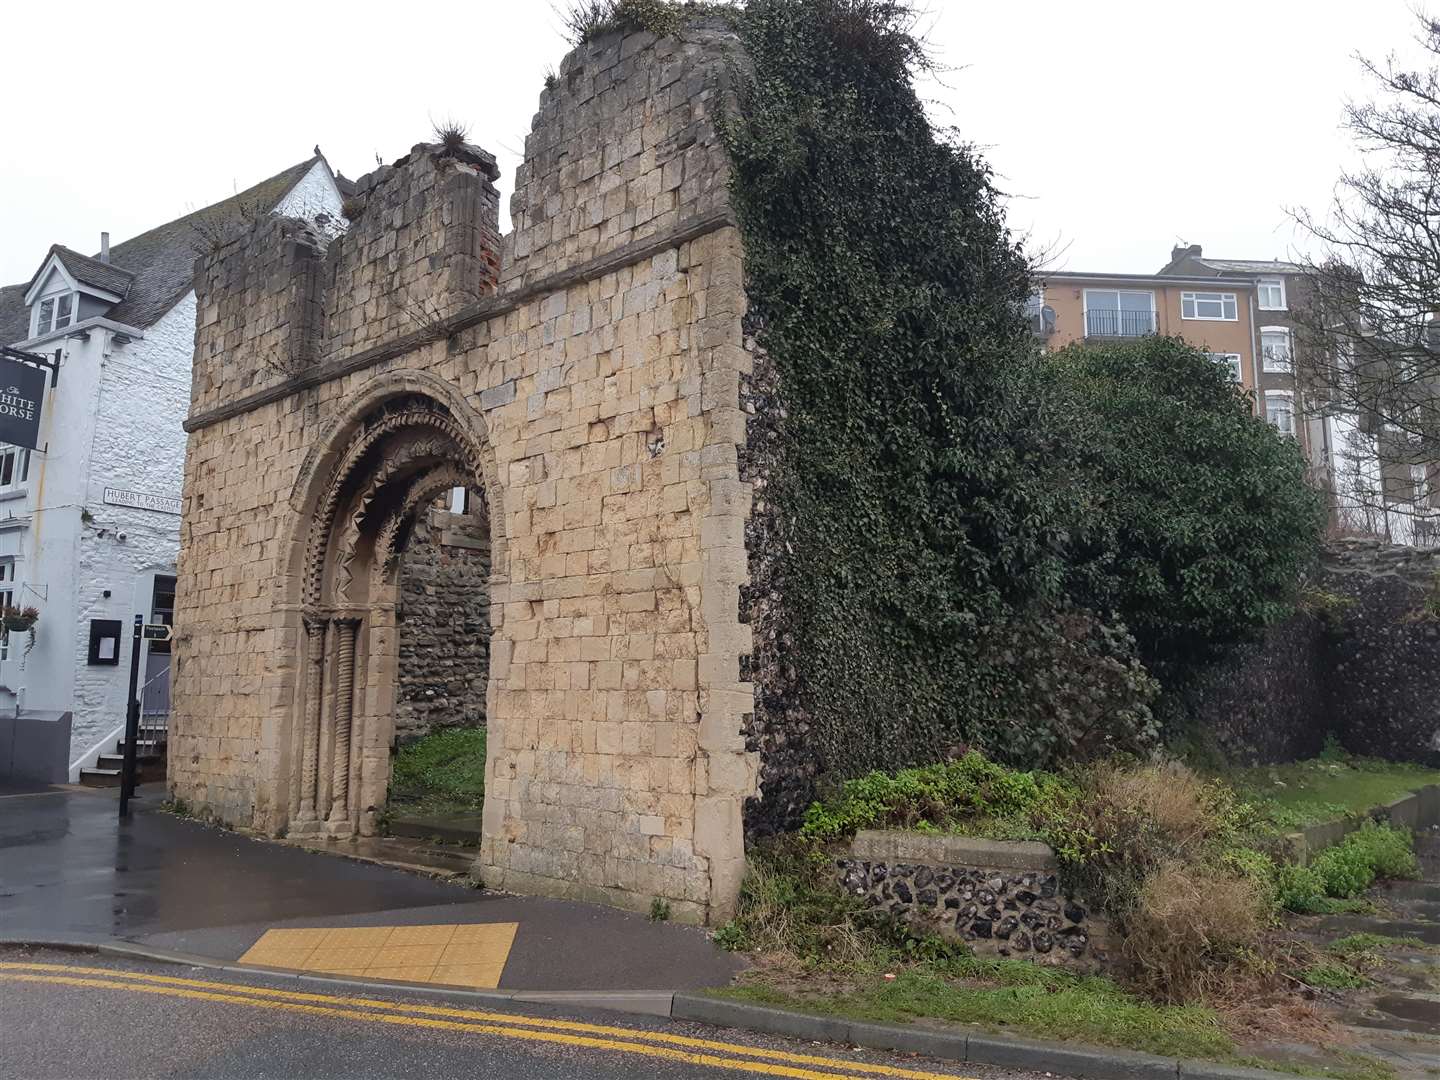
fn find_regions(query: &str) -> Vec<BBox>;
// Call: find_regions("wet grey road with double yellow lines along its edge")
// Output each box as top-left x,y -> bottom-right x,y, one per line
0,949 -> 1065,1080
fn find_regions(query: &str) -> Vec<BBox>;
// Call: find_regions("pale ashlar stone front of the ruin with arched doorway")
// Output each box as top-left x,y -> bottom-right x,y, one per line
170,22 -> 757,922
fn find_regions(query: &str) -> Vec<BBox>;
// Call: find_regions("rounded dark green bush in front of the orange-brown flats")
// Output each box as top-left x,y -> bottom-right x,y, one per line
1045,337 -> 1323,680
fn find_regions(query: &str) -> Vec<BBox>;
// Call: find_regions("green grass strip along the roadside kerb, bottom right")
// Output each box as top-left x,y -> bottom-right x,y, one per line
716,963 -> 1234,1057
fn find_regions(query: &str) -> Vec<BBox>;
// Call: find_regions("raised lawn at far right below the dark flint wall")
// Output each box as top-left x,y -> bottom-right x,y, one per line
1225,757 -> 1440,829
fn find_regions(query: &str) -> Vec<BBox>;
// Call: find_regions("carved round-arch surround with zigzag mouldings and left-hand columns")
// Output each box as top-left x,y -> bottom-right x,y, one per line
276,373 -> 498,838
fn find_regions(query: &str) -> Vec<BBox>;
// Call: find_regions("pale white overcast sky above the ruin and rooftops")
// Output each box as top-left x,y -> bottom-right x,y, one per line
0,0 -> 1413,282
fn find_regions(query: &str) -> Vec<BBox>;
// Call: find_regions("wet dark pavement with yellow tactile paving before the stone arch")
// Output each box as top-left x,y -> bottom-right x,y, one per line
0,788 -> 742,991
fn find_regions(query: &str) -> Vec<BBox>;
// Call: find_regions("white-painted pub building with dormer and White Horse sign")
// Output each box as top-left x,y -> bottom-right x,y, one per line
0,148 -> 346,782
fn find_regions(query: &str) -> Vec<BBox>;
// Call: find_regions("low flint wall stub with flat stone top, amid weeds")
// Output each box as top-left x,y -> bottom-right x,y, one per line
835,831 -> 1110,968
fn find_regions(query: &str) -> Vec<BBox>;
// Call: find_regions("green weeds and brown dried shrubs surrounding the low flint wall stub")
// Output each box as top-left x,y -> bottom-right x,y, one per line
716,752 -> 1417,1047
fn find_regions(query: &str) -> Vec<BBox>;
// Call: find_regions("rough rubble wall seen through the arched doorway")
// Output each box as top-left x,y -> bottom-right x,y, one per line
395,510 -> 491,742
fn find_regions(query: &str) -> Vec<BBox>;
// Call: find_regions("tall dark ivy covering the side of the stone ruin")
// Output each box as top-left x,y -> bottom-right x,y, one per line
724,0 -> 1155,775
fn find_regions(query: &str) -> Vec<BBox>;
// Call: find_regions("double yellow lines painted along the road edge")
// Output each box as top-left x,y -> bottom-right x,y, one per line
0,962 -> 979,1080
